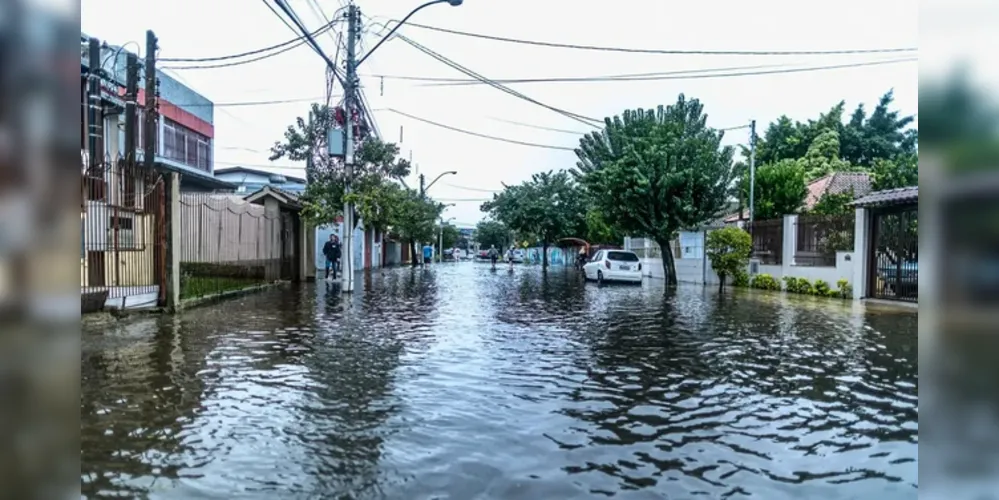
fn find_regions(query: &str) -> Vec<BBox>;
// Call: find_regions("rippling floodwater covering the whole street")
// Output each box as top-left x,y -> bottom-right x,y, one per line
81,263 -> 918,500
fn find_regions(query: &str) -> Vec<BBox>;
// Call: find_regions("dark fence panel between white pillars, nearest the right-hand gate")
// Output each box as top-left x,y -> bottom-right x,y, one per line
794,214 -> 855,267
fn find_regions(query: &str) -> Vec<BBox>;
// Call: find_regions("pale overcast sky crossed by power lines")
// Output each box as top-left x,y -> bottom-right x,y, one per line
82,0 -> 919,223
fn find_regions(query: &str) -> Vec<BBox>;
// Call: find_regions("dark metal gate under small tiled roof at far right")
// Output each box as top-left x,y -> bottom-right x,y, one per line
868,205 -> 919,302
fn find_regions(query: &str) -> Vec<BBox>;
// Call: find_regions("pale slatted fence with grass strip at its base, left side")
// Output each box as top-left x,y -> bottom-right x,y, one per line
178,193 -> 295,300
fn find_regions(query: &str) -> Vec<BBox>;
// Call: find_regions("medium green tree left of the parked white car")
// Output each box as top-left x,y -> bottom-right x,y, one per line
482,170 -> 585,269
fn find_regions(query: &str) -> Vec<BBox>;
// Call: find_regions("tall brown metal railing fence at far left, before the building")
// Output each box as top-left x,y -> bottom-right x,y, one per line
80,158 -> 166,310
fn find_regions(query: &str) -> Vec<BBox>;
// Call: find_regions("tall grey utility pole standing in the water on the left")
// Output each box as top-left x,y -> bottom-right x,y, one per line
340,3 -> 360,293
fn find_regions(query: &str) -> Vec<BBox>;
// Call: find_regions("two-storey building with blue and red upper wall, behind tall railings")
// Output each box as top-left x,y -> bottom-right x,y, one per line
80,33 -> 235,309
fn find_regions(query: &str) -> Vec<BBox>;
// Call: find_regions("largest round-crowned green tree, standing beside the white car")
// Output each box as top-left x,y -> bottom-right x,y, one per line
577,94 -> 733,285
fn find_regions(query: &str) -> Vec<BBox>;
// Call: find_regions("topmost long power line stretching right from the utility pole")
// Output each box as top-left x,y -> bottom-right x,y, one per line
402,19 -> 918,56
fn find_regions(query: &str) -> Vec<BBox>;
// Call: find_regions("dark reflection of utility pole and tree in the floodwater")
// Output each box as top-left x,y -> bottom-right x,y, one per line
297,270 -> 438,497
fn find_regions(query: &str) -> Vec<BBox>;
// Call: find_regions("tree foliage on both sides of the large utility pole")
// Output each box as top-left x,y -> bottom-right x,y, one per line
270,104 -> 410,229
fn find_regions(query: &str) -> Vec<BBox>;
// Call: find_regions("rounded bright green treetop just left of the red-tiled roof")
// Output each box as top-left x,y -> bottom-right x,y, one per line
742,160 -> 808,220
